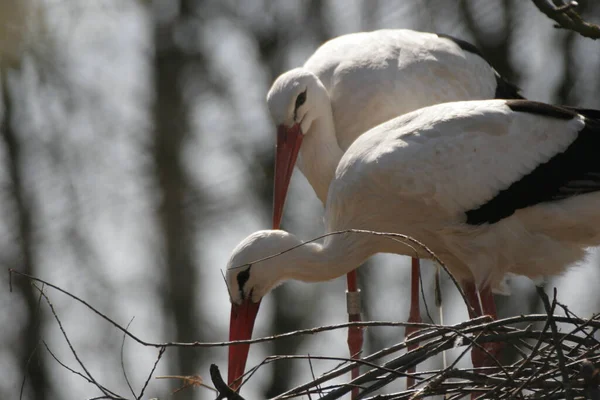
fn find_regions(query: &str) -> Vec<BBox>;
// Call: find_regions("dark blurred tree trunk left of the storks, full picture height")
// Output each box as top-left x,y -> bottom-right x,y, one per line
154,1 -> 200,399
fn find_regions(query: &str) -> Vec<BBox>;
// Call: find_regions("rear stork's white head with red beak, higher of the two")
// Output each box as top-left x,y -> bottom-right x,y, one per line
267,68 -> 330,229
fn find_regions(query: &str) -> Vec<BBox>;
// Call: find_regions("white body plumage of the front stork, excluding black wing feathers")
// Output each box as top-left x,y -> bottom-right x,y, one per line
326,101 -> 600,287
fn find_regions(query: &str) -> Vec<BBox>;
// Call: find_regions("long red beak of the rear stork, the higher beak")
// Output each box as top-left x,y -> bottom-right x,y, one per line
273,124 -> 303,229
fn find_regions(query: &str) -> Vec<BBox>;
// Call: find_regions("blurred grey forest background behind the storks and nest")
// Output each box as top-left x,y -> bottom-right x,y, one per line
0,0 -> 600,400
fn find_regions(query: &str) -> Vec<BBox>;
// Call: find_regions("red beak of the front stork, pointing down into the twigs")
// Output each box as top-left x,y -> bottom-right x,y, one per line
227,300 -> 260,390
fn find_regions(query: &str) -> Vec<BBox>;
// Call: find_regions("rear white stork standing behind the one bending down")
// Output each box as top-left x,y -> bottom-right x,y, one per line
241,29 -> 520,390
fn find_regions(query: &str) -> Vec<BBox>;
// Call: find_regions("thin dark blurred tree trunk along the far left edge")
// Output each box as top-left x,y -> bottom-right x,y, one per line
0,69 -> 50,400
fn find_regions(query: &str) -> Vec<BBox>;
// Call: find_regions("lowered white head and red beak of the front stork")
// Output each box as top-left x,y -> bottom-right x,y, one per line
225,230 -> 301,390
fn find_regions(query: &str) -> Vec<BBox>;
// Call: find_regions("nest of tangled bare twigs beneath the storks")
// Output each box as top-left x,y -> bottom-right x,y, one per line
211,288 -> 600,400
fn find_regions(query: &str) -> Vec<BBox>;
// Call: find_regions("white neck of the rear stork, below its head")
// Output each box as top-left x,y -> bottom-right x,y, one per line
298,95 -> 344,204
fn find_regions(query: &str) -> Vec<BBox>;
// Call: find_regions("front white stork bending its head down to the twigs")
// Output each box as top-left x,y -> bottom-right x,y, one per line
226,98 -> 600,392
